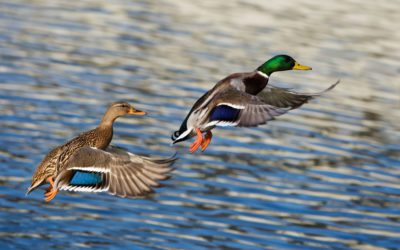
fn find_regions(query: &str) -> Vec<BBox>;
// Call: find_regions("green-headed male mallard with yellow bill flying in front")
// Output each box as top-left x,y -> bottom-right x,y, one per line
171,55 -> 337,153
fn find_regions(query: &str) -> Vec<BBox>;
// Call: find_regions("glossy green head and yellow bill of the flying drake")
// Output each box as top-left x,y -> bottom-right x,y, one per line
257,55 -> 311,76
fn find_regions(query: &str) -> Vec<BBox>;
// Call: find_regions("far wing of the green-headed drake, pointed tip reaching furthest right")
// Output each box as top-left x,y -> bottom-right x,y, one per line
257,81 -> 340,109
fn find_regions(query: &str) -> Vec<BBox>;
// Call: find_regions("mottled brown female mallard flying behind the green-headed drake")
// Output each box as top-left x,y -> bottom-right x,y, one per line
27,102 -> 176,202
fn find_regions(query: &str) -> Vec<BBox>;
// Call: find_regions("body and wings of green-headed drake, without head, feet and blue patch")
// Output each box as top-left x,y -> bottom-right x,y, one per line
171,71 -> 339,143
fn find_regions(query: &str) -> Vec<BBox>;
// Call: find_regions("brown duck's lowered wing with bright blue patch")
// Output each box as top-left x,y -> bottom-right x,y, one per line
55,146 -> 176,197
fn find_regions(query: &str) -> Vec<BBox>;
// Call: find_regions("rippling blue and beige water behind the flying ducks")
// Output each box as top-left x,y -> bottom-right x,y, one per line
0,0 -> 400,249
